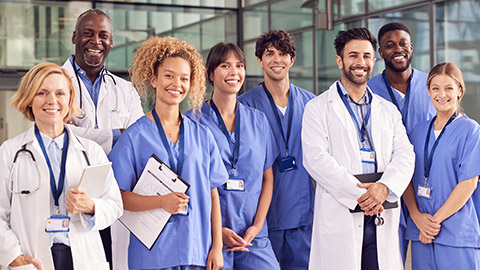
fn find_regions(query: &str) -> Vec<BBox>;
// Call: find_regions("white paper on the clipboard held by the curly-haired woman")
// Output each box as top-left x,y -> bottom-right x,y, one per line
119,154 -> 190,250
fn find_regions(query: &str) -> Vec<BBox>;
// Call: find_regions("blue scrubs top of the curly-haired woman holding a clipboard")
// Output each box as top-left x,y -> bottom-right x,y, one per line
108,116 -> 228,269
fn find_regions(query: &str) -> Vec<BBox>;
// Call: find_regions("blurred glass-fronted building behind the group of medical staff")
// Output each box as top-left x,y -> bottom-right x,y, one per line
0,0 -> 480,142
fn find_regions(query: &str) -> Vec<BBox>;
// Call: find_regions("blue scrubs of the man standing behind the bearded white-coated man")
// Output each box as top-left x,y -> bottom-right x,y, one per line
367,68 -> 436,263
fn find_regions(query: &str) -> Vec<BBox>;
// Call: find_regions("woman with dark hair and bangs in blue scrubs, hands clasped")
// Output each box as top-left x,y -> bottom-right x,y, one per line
187,43 -> 279,270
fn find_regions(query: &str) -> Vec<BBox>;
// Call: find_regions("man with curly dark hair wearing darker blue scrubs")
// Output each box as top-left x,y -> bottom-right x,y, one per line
238,30 -> 314,269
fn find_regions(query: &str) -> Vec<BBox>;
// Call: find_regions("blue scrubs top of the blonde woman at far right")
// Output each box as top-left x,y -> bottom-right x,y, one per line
406,115 -> 480,248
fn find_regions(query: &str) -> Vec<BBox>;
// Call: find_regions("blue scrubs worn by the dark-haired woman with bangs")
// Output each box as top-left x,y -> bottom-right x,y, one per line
185,102 -> 279,269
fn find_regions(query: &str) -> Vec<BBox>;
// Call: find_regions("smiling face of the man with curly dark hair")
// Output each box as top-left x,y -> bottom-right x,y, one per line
257,46 -> 295,81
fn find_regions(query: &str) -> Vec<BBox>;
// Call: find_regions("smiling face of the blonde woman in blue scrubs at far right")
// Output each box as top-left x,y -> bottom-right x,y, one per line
428,74 -> 463,114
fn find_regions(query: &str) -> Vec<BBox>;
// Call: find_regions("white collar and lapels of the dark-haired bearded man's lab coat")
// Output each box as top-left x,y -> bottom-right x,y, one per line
327,81 -> 384,172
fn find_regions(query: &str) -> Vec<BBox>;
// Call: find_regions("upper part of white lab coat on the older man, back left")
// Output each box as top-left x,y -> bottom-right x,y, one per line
62,58 -> 144,154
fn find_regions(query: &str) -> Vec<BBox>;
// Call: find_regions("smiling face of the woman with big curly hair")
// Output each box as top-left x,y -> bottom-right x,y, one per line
150,57 -> 191,106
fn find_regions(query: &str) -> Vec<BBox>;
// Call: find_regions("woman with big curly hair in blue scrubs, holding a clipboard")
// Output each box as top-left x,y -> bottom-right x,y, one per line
109,37 -> 228,270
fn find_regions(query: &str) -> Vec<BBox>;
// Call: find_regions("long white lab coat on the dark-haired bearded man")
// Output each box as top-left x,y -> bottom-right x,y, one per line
302,83 -> 415,270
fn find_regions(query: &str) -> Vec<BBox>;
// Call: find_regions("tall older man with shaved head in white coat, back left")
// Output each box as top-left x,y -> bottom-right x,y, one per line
63,9 -> 144,270
